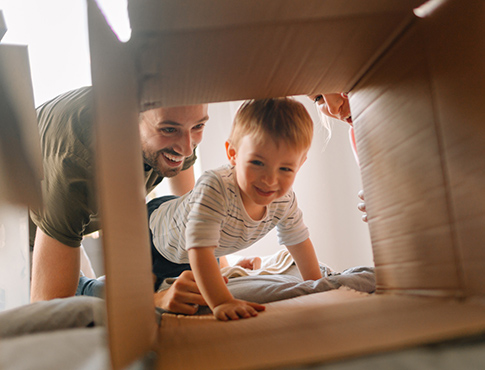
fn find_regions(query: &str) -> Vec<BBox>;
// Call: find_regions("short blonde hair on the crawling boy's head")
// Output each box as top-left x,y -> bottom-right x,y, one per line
228,97 -> 313,151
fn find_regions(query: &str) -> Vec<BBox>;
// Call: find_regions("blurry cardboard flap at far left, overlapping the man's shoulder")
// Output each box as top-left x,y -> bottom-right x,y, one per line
0,44 -> 43,207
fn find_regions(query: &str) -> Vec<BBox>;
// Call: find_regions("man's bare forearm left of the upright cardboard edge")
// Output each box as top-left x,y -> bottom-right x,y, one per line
30,228 -> 81,302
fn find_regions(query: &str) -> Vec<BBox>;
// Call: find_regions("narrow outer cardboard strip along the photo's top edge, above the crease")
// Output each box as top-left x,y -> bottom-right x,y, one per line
128,0 -> 425,36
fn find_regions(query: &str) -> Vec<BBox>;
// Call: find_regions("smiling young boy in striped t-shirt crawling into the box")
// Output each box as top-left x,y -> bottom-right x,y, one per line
148,98 -> 322,321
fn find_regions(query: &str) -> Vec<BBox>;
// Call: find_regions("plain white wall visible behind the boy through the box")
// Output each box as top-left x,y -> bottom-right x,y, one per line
198,97 -> 373,271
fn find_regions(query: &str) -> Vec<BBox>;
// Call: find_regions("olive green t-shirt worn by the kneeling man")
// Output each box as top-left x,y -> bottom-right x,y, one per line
30,87 -> 196,247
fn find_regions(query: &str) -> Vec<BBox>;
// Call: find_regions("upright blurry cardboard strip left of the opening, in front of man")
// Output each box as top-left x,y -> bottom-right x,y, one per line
88,0 -> 157,369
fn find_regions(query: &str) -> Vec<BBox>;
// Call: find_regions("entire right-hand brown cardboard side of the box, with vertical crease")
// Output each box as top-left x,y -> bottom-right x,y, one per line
352,2 -> 485,297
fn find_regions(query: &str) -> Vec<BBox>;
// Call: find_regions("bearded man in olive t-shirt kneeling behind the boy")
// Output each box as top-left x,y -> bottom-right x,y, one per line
31,87 -> 209,312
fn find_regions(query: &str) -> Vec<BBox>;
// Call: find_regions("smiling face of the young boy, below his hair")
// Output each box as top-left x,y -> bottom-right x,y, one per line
226,135 -> 307,215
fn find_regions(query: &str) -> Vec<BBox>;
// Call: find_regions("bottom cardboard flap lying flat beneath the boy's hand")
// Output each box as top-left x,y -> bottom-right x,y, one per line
158,290 -> 485,370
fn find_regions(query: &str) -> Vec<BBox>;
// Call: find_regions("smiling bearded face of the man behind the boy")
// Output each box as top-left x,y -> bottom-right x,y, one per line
139,104 -> 209,177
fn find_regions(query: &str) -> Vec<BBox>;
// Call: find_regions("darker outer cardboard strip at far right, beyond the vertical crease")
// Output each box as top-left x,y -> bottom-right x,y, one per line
423,1 -> 485,296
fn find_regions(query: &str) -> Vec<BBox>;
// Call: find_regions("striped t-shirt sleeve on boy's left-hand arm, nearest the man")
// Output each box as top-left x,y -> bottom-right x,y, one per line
185,171 -> 227,250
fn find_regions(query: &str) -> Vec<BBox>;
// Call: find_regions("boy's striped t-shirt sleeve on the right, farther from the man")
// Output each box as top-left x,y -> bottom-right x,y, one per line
276,192 -> 310,246
